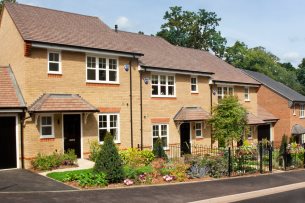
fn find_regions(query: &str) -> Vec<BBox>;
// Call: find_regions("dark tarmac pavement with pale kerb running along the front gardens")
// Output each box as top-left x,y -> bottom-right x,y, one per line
0,170 -> 305,203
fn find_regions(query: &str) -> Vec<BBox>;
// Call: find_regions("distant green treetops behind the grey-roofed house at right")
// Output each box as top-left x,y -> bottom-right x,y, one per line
225,41 -> 305,94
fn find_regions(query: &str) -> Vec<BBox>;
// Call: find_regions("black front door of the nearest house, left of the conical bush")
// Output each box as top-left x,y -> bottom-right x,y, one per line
64,114 -> 81,158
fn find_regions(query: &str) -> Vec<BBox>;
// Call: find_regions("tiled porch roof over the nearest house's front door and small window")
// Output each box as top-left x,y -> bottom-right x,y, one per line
28,94 -> 99,112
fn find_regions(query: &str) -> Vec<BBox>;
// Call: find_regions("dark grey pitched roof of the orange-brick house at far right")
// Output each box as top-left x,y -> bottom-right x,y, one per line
242,70 -> 305,102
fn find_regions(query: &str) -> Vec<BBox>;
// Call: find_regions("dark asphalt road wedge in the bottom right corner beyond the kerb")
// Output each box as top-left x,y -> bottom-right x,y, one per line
239,188 -> 305,203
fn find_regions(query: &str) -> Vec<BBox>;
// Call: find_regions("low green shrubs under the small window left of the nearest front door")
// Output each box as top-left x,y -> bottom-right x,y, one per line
32,150 -> 77,171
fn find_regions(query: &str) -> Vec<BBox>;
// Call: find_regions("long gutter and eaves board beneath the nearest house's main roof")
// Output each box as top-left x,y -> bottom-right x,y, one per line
31,42 -> 144,58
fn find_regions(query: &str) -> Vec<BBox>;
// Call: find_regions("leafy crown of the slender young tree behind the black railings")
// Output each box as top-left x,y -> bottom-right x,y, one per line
209,96 -> 247,146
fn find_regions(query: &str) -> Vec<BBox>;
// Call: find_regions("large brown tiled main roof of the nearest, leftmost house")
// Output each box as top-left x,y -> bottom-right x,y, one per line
5,3 -> 139,53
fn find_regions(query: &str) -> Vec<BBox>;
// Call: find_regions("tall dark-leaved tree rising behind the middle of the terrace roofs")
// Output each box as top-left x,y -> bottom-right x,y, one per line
157,6 -> 227,57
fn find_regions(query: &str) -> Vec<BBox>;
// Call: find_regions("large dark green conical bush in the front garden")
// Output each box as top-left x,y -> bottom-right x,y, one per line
94,132 -> 124,183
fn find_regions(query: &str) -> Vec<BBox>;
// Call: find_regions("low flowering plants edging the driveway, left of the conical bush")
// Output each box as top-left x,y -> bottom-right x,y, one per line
63,171 -> 108,187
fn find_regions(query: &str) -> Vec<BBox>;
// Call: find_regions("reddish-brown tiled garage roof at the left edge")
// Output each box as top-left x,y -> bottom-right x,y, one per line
0,67 -> 26,108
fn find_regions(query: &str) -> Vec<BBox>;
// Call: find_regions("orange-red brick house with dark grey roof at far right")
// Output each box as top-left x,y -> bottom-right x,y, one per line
244,70 -> 305,146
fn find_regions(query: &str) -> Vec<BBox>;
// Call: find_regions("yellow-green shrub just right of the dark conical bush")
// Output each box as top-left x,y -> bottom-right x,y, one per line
119,148 -> 155,167
